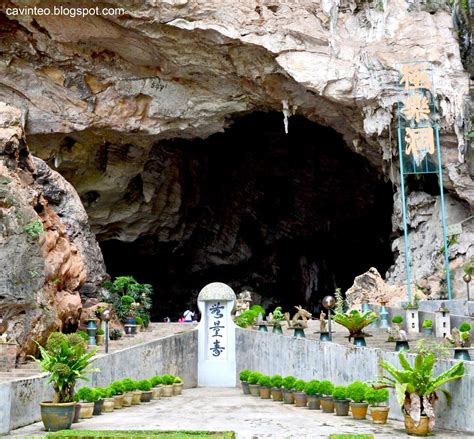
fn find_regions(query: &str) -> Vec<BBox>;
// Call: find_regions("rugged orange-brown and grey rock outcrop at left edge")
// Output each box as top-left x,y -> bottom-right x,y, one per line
0,104 -> 101,356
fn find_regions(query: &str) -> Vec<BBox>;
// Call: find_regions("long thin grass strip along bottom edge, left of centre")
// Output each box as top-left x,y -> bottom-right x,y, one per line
46,430 -> 235,439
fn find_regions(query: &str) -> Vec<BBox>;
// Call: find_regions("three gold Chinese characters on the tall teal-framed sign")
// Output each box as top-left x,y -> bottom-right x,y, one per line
399,63 -> 437,174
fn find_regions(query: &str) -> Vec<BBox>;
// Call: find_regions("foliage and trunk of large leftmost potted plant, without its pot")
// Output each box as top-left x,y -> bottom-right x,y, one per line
31,332 -> 99,403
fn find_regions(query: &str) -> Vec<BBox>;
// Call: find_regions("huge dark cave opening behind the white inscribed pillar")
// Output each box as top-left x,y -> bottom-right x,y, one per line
100,112 -> 393,320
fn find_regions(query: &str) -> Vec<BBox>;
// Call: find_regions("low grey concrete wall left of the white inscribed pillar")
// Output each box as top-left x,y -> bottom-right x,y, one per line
0,331 -> 197,434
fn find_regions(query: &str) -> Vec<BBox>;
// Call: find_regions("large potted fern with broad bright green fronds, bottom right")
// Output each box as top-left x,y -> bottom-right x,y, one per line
379,353 -> 464,436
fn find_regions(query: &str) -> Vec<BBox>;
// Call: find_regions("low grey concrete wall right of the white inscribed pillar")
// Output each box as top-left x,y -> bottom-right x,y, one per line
236,329 -> 474,432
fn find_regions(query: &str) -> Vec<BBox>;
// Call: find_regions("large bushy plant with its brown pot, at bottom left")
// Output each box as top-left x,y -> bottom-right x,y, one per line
32,332 -> 98,431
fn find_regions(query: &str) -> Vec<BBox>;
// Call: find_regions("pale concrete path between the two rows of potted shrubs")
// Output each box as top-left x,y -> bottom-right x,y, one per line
8,388 -> 474,439
